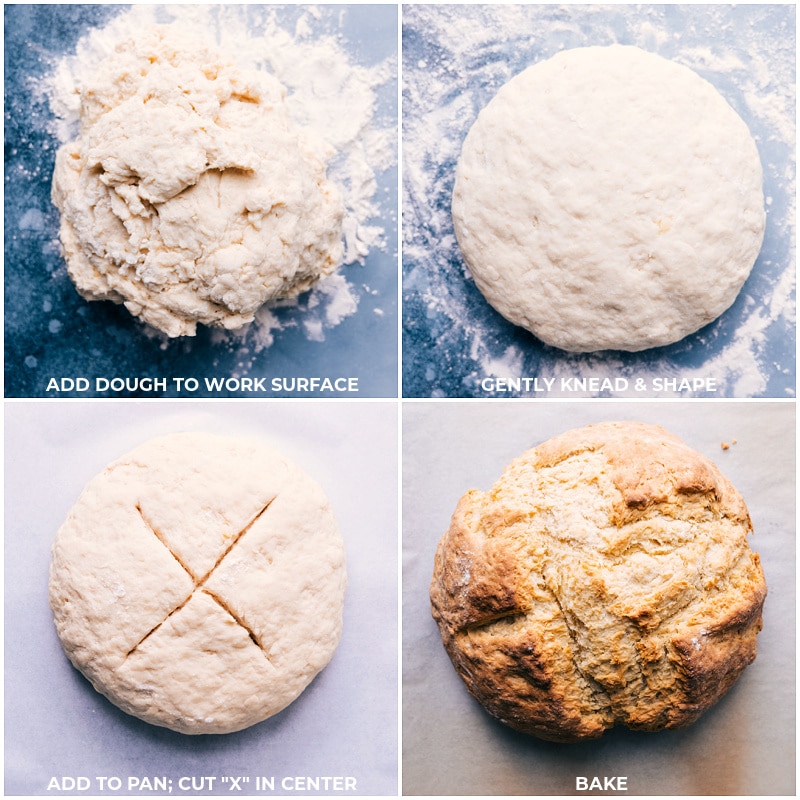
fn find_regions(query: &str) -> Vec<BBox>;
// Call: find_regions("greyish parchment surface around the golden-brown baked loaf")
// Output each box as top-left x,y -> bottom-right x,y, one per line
402,400 -> 796,796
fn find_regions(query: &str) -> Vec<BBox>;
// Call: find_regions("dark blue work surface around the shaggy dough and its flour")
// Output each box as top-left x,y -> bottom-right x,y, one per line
4,4 -> 398,398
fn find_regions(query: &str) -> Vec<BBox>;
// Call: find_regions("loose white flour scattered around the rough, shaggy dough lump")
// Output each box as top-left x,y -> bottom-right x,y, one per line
41,5 -> 396,355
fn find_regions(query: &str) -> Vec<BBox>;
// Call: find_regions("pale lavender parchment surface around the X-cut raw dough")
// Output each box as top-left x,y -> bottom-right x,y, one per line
5,401 -> 398,796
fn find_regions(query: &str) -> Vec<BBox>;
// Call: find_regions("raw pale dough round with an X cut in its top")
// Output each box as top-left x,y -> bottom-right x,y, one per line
50,433 -> 346,734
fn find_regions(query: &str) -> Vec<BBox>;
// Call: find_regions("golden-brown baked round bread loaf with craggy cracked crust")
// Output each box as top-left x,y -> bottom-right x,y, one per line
431,423 -> 767,742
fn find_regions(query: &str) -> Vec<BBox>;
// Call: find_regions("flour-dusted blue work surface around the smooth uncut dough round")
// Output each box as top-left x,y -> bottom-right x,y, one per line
402,4 -> 796,398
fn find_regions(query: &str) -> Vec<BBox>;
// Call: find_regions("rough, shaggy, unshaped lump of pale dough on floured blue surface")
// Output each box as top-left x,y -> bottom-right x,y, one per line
52,26 -> 343,337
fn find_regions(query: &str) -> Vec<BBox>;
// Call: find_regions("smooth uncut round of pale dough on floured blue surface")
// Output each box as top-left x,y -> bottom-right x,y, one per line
452,45 -> 765,352
